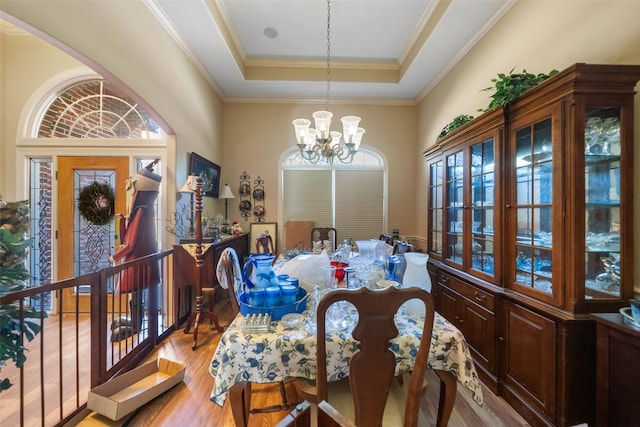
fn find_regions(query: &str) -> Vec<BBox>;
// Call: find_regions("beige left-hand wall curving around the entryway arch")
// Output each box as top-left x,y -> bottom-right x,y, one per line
0,0 -> 223,224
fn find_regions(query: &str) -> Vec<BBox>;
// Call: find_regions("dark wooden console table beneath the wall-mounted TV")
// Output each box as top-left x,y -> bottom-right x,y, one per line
173,233 -> 249,324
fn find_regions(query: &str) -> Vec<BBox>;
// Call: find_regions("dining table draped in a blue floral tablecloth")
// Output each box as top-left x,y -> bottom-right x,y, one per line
209,290 -> 483,427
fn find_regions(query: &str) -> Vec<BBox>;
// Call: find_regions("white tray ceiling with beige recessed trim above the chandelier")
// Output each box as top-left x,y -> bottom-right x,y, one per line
150,0 -> 516,102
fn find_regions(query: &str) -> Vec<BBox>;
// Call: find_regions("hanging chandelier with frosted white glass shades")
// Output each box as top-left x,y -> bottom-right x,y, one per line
293,0 -> 365,164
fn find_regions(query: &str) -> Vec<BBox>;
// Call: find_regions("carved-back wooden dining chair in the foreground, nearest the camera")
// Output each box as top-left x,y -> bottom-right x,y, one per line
300,287 -> 435,427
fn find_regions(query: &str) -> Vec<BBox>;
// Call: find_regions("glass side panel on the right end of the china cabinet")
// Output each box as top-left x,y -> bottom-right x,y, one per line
584,108 -> 622,299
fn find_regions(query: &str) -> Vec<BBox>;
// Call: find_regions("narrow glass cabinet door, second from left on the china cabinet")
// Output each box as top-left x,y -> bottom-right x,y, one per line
445,151 -> 464,265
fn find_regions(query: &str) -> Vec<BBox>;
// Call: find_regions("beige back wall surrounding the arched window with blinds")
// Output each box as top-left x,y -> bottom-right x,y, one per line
222,103 -> 420,247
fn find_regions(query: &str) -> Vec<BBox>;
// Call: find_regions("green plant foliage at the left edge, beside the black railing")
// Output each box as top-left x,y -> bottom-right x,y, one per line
0,197 -> 44,392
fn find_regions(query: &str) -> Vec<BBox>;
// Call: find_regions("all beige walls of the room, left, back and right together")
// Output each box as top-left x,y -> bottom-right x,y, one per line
0,0 -> 640,288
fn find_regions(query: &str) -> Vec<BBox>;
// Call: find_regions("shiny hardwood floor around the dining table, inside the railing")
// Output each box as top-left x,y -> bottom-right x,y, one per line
77,292 -> 529,427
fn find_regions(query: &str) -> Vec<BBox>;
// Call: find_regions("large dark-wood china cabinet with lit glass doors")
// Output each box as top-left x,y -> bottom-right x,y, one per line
423,64 -> 640,425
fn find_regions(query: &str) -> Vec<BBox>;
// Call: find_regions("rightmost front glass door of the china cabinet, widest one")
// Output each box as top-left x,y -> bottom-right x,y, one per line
511,118 -> 561,295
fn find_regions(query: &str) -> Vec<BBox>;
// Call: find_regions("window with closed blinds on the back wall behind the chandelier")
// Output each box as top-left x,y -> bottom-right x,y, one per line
281,147 -> 388,249
